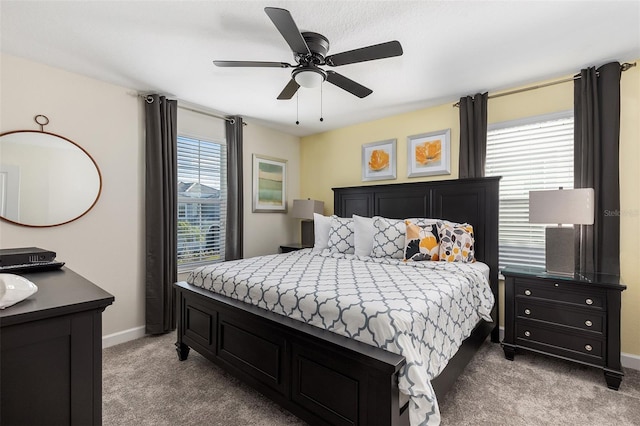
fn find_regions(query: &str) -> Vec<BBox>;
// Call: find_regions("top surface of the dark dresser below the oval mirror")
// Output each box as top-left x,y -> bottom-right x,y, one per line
0,267 -> 114,326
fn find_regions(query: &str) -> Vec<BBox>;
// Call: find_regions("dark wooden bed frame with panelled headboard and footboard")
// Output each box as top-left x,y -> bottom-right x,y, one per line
175,178 -> 499,425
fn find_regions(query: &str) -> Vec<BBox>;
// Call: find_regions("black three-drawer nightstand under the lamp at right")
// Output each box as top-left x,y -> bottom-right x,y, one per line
502,267 -> 626,390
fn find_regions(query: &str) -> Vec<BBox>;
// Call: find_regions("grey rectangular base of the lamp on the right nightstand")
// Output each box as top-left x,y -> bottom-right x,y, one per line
545,226 -> 576,276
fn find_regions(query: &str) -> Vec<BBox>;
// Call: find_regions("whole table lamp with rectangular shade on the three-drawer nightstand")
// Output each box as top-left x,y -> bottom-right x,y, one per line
529,188 -> 595,275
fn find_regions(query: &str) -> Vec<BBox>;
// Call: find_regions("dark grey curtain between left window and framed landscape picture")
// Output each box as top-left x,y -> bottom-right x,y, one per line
224,116 -> 243,260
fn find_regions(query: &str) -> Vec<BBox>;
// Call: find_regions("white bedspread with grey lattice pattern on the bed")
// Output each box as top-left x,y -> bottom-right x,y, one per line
187,249 -> 494,426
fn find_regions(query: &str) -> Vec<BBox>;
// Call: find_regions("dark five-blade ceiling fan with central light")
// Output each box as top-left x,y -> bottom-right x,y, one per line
213,7 -> 402,99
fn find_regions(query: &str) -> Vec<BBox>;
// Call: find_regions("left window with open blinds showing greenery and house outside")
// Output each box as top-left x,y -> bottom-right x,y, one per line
178,136 -> 227,270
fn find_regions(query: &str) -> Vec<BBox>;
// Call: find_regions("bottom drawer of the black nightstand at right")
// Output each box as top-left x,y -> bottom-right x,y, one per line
516,321 -> 604,364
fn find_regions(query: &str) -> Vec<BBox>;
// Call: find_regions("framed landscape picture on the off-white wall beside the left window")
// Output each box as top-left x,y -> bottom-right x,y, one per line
252,154 -> 287,213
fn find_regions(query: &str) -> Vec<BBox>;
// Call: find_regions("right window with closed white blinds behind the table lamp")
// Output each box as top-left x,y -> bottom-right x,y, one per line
485,112 -> 573,269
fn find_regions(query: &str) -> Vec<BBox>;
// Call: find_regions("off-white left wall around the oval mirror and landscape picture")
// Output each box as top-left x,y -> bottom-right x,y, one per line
0,54 -> 300,342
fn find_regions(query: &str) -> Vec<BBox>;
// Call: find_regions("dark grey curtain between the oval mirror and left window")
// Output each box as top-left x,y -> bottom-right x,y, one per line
145,95 -> 178,334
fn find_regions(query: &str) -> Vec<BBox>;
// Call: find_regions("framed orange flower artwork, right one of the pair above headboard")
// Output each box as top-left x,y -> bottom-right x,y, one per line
407,129 -> 451,177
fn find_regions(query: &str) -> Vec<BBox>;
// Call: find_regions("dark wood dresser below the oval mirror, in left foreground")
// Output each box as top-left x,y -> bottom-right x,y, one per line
0,268 -> 114,425
